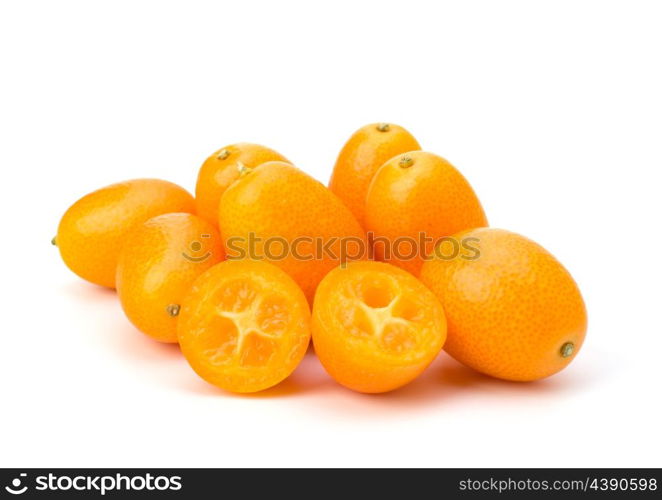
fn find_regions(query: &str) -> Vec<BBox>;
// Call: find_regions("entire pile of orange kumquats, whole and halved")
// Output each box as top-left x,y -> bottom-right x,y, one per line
53,123 -> 587,393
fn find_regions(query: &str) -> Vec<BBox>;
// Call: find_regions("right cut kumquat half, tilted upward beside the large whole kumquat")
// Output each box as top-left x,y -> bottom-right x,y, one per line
313,261 -> 446,393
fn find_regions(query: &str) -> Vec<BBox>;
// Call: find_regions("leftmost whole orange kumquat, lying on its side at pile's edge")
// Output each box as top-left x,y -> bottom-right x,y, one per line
56,179 -> 195,288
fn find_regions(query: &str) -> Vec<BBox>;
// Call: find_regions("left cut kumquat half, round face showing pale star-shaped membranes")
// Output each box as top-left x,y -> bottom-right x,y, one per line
177,260 -> 310,392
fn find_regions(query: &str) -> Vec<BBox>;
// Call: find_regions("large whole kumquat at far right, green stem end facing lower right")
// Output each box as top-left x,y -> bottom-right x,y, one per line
420,228 -> 587,381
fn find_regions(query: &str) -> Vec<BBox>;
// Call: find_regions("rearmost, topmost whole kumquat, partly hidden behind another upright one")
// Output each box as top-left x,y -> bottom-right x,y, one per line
329,123 -> 421,227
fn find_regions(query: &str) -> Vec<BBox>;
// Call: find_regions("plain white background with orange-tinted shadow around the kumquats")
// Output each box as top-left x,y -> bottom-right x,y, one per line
0,0 -> 662,467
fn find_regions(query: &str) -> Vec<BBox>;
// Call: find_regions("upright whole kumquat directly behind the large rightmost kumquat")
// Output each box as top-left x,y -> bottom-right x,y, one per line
366,151 -> 487,275
